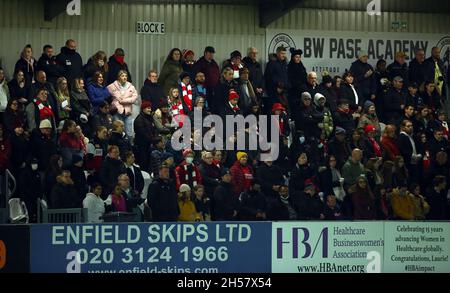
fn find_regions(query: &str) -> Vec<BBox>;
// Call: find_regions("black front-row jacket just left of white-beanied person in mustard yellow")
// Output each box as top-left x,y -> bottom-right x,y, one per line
147,178 -> 180,222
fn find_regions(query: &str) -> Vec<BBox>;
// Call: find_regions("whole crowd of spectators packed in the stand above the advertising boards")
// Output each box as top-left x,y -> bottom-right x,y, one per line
0,40 -> 450,222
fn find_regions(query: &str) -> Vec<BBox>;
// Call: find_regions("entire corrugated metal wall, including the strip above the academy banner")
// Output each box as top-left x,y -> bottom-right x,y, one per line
0,0 -> 450,87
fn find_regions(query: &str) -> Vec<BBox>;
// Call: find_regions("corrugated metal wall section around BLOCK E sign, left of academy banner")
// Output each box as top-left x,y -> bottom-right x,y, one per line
0,0 -> 265,87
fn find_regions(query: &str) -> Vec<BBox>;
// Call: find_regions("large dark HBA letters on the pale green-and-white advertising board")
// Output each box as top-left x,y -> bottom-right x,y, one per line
277,227 -> 328,259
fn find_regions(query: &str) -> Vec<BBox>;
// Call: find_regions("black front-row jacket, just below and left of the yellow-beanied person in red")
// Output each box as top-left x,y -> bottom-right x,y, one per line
211,182 -> 238,221
